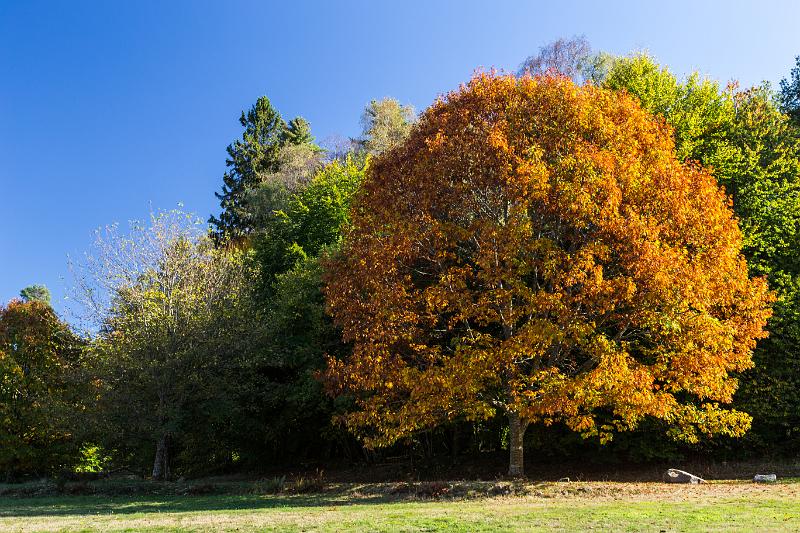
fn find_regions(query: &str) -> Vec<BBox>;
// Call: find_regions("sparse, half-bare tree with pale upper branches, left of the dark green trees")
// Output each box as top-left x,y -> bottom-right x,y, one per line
78,212 -> 253,479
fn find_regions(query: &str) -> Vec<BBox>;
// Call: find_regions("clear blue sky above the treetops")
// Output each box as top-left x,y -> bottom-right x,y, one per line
0,0 -> 800,316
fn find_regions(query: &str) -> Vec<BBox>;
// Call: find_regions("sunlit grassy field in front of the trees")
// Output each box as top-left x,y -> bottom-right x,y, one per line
0,480 -> 800,531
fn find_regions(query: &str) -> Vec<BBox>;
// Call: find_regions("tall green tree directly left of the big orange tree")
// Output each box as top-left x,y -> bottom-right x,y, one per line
238,157 -> 369,460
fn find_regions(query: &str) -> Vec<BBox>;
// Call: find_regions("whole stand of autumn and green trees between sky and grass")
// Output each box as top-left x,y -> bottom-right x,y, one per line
0,38 -> 800,482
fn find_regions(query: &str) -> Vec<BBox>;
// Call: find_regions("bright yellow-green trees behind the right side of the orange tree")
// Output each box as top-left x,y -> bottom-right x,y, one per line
598,54 -> 800,453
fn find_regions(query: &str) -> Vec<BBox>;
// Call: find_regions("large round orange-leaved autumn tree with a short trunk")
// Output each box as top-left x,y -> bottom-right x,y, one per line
325,74 -> 770,476
